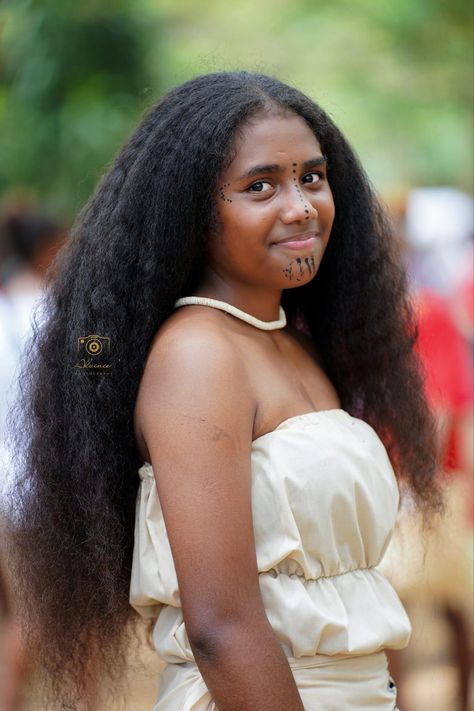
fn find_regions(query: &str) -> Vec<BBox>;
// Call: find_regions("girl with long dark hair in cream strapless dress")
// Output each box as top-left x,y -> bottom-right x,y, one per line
3,71 -> 440,711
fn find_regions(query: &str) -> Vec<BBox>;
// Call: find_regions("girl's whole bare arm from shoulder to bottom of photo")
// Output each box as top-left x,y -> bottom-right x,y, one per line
142,327 -> 303,711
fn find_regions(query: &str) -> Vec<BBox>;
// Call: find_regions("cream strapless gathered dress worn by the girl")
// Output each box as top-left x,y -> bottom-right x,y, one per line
130,410 -> 411,711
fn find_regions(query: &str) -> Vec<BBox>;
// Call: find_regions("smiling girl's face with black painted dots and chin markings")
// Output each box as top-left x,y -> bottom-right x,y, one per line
208,114 -> 334,290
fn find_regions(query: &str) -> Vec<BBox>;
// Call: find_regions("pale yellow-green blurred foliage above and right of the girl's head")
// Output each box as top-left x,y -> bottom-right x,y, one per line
147,0 -> 473,191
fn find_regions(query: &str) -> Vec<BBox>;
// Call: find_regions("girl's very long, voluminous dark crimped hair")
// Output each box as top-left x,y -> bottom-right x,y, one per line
3,71 -> 441,698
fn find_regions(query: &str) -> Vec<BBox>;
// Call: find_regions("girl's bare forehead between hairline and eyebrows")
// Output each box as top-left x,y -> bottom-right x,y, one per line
228,114 -> 321,173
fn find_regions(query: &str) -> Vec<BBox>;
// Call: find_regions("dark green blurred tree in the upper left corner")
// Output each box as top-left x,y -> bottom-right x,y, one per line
0,0 -> 161,214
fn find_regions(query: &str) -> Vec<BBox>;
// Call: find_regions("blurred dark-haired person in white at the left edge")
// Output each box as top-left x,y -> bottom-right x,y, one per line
0,204 -> 65,711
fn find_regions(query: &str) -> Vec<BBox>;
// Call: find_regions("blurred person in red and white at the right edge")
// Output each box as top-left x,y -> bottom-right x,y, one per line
405,187 -> 474,521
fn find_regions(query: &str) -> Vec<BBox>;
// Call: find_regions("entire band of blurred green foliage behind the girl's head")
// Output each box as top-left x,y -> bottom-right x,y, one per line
0,0 -> 473,217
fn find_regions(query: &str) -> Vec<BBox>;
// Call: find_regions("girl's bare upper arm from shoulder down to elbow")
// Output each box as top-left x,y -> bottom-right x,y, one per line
142,330 -> 261,635
